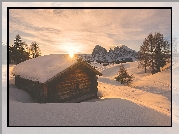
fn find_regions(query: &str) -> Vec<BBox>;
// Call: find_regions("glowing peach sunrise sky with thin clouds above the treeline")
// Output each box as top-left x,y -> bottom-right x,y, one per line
9,9 -> 171,55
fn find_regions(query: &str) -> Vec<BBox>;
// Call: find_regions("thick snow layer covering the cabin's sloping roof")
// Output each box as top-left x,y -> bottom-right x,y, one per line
13,54 -> 77,83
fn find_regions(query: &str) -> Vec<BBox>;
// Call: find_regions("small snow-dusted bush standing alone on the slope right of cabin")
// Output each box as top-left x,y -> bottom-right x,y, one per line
115,64 -> 134,85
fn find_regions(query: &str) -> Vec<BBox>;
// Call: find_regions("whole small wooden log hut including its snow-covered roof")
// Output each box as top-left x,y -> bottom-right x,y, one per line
14,55 -> 102,103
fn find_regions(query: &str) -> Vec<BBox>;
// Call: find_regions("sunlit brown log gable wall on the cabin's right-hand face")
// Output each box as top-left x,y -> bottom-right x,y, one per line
48,66 -> 97,102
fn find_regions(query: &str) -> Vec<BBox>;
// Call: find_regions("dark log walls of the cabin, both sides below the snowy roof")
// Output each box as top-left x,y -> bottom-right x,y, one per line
15,65 -> 98,102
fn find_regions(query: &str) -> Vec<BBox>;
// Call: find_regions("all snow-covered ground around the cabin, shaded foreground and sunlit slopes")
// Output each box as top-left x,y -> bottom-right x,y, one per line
3,59 -> 173,126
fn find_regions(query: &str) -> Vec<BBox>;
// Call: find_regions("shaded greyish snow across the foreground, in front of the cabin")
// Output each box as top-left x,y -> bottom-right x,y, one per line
9,66 -> 170,126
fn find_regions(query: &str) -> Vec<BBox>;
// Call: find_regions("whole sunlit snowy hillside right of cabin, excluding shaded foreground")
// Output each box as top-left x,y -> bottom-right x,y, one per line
98,62 -> 171,116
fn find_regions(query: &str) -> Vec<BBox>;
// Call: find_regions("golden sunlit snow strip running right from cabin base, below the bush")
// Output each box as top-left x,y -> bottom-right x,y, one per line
98,79 -> 171,116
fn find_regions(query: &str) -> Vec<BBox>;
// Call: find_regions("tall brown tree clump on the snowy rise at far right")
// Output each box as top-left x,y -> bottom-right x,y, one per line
139,33 -> 170,74
